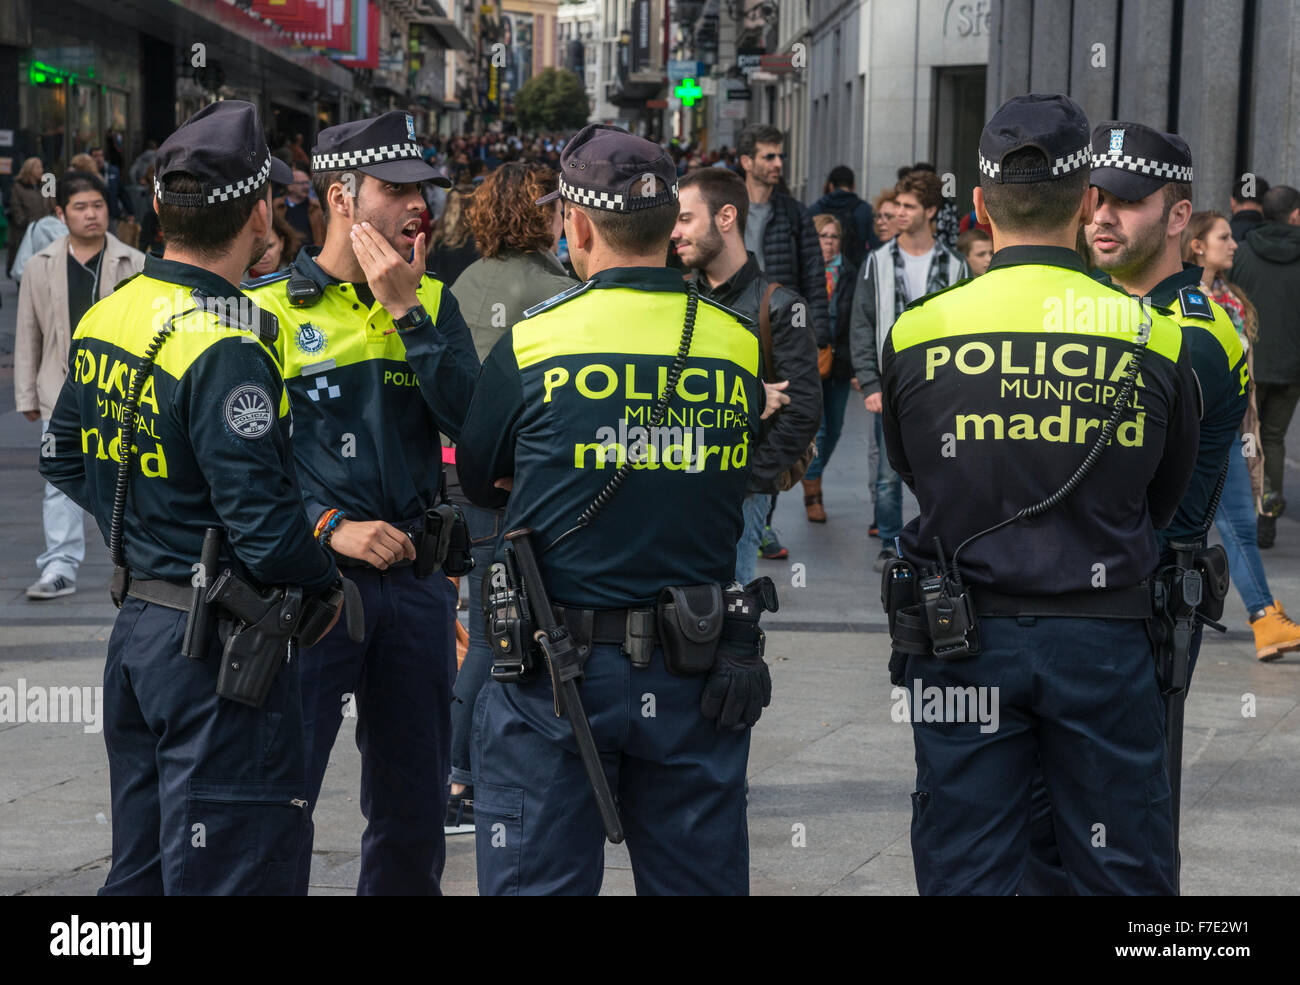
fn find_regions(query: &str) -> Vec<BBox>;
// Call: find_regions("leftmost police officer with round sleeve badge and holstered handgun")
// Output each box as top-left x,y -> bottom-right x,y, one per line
40,100 -> 338,895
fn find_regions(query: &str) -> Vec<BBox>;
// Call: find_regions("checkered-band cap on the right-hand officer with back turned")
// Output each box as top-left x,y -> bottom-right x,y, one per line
979,92 -> 1092,185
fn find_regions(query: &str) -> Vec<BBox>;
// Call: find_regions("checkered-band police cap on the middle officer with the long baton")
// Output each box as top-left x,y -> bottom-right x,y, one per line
537,123 -> 677,212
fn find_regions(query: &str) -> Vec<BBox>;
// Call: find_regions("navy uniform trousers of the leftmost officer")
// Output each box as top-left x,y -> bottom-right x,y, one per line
100,598 -> 307,895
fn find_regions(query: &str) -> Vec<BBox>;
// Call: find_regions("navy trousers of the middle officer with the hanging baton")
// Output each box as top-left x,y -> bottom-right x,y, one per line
472,645 -> 749,895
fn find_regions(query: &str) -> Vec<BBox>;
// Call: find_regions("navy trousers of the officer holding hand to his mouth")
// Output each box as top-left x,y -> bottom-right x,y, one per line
296,565 -> 456,895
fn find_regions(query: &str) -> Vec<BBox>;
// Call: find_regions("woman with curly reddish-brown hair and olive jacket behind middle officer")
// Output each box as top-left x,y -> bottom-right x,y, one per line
445,162 -> 577,834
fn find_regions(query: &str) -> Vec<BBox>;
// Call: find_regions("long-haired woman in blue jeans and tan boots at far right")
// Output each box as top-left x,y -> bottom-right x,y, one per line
1183,212 -> 1300,660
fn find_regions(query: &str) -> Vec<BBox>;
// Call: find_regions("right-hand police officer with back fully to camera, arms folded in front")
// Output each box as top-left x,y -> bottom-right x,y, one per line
883,95 -> 1199,894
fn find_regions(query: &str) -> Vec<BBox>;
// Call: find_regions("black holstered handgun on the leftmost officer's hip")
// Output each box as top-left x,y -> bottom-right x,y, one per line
208,568 -> 343,708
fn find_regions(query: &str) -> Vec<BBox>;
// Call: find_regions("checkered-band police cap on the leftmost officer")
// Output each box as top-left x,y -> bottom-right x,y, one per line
153,99 -> 294,208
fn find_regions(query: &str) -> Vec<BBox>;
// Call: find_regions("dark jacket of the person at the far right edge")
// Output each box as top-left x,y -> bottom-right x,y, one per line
1232,222 -> 1300,383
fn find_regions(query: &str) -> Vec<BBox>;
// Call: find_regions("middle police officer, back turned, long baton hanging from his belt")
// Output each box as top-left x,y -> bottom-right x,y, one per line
456,125 -> 774,894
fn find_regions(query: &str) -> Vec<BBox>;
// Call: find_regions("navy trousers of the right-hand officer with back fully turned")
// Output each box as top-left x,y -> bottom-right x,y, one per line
905,619 -> 1174,895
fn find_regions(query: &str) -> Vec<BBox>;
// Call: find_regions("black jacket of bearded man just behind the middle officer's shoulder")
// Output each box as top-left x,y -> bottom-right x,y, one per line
696,253 -> 816,493
